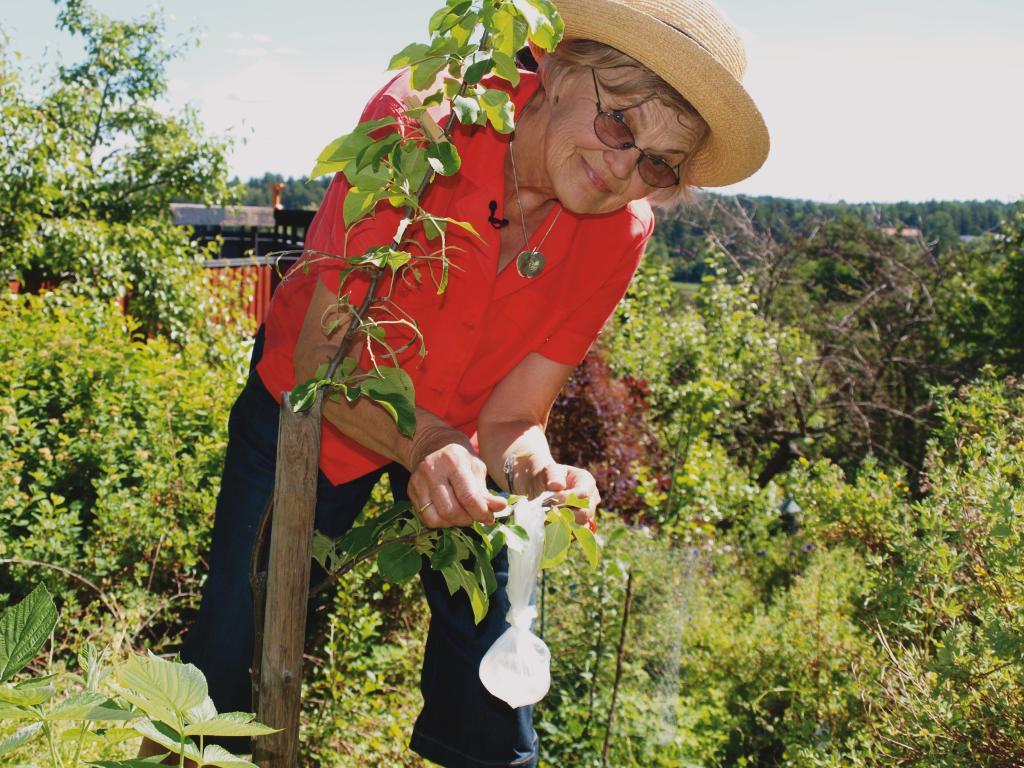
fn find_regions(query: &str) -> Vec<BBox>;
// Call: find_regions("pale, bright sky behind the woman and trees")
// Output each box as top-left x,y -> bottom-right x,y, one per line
0,0 -> 1024,202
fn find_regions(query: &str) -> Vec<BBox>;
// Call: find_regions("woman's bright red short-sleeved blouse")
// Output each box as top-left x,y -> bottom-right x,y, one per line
256,72 -> 654,484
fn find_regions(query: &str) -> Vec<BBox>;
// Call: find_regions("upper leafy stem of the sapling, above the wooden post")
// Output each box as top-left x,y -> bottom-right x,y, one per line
295,0 -> 563,442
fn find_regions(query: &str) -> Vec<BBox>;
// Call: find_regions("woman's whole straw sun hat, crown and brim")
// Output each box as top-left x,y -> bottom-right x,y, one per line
557,0 -> 768,186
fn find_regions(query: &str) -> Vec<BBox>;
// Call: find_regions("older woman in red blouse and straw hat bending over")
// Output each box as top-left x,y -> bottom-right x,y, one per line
161,0 -> 768,768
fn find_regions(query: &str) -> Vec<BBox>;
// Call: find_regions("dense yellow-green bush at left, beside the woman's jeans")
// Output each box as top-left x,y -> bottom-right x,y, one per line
0,293 -> 245,631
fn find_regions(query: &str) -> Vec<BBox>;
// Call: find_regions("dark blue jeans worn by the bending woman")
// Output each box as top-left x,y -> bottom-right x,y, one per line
181,330 -> 538,768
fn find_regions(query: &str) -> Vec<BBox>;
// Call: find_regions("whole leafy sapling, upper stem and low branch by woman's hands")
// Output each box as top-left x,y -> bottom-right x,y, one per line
292,0 -> 597,622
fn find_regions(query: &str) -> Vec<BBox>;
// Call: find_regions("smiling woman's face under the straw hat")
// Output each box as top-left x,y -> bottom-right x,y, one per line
544,69 -> 696,214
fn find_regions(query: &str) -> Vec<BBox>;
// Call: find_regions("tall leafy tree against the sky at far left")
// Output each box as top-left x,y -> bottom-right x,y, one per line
0,0 -> 237,341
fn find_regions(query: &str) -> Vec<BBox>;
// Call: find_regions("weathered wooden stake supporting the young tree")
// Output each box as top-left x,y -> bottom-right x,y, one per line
253,390 -> 324,768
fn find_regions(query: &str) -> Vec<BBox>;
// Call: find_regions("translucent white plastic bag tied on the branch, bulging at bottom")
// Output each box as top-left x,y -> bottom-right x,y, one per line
480,494 -> 551,707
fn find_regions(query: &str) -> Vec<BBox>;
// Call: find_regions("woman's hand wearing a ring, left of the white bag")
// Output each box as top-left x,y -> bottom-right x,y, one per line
408,425 -> 508,528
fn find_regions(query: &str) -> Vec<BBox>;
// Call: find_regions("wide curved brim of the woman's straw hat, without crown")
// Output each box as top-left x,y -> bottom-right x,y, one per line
558,0 -> 769,186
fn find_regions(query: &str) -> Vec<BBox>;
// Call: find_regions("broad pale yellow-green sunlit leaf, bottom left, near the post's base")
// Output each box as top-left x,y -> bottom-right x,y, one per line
116,655 -> 207,723
